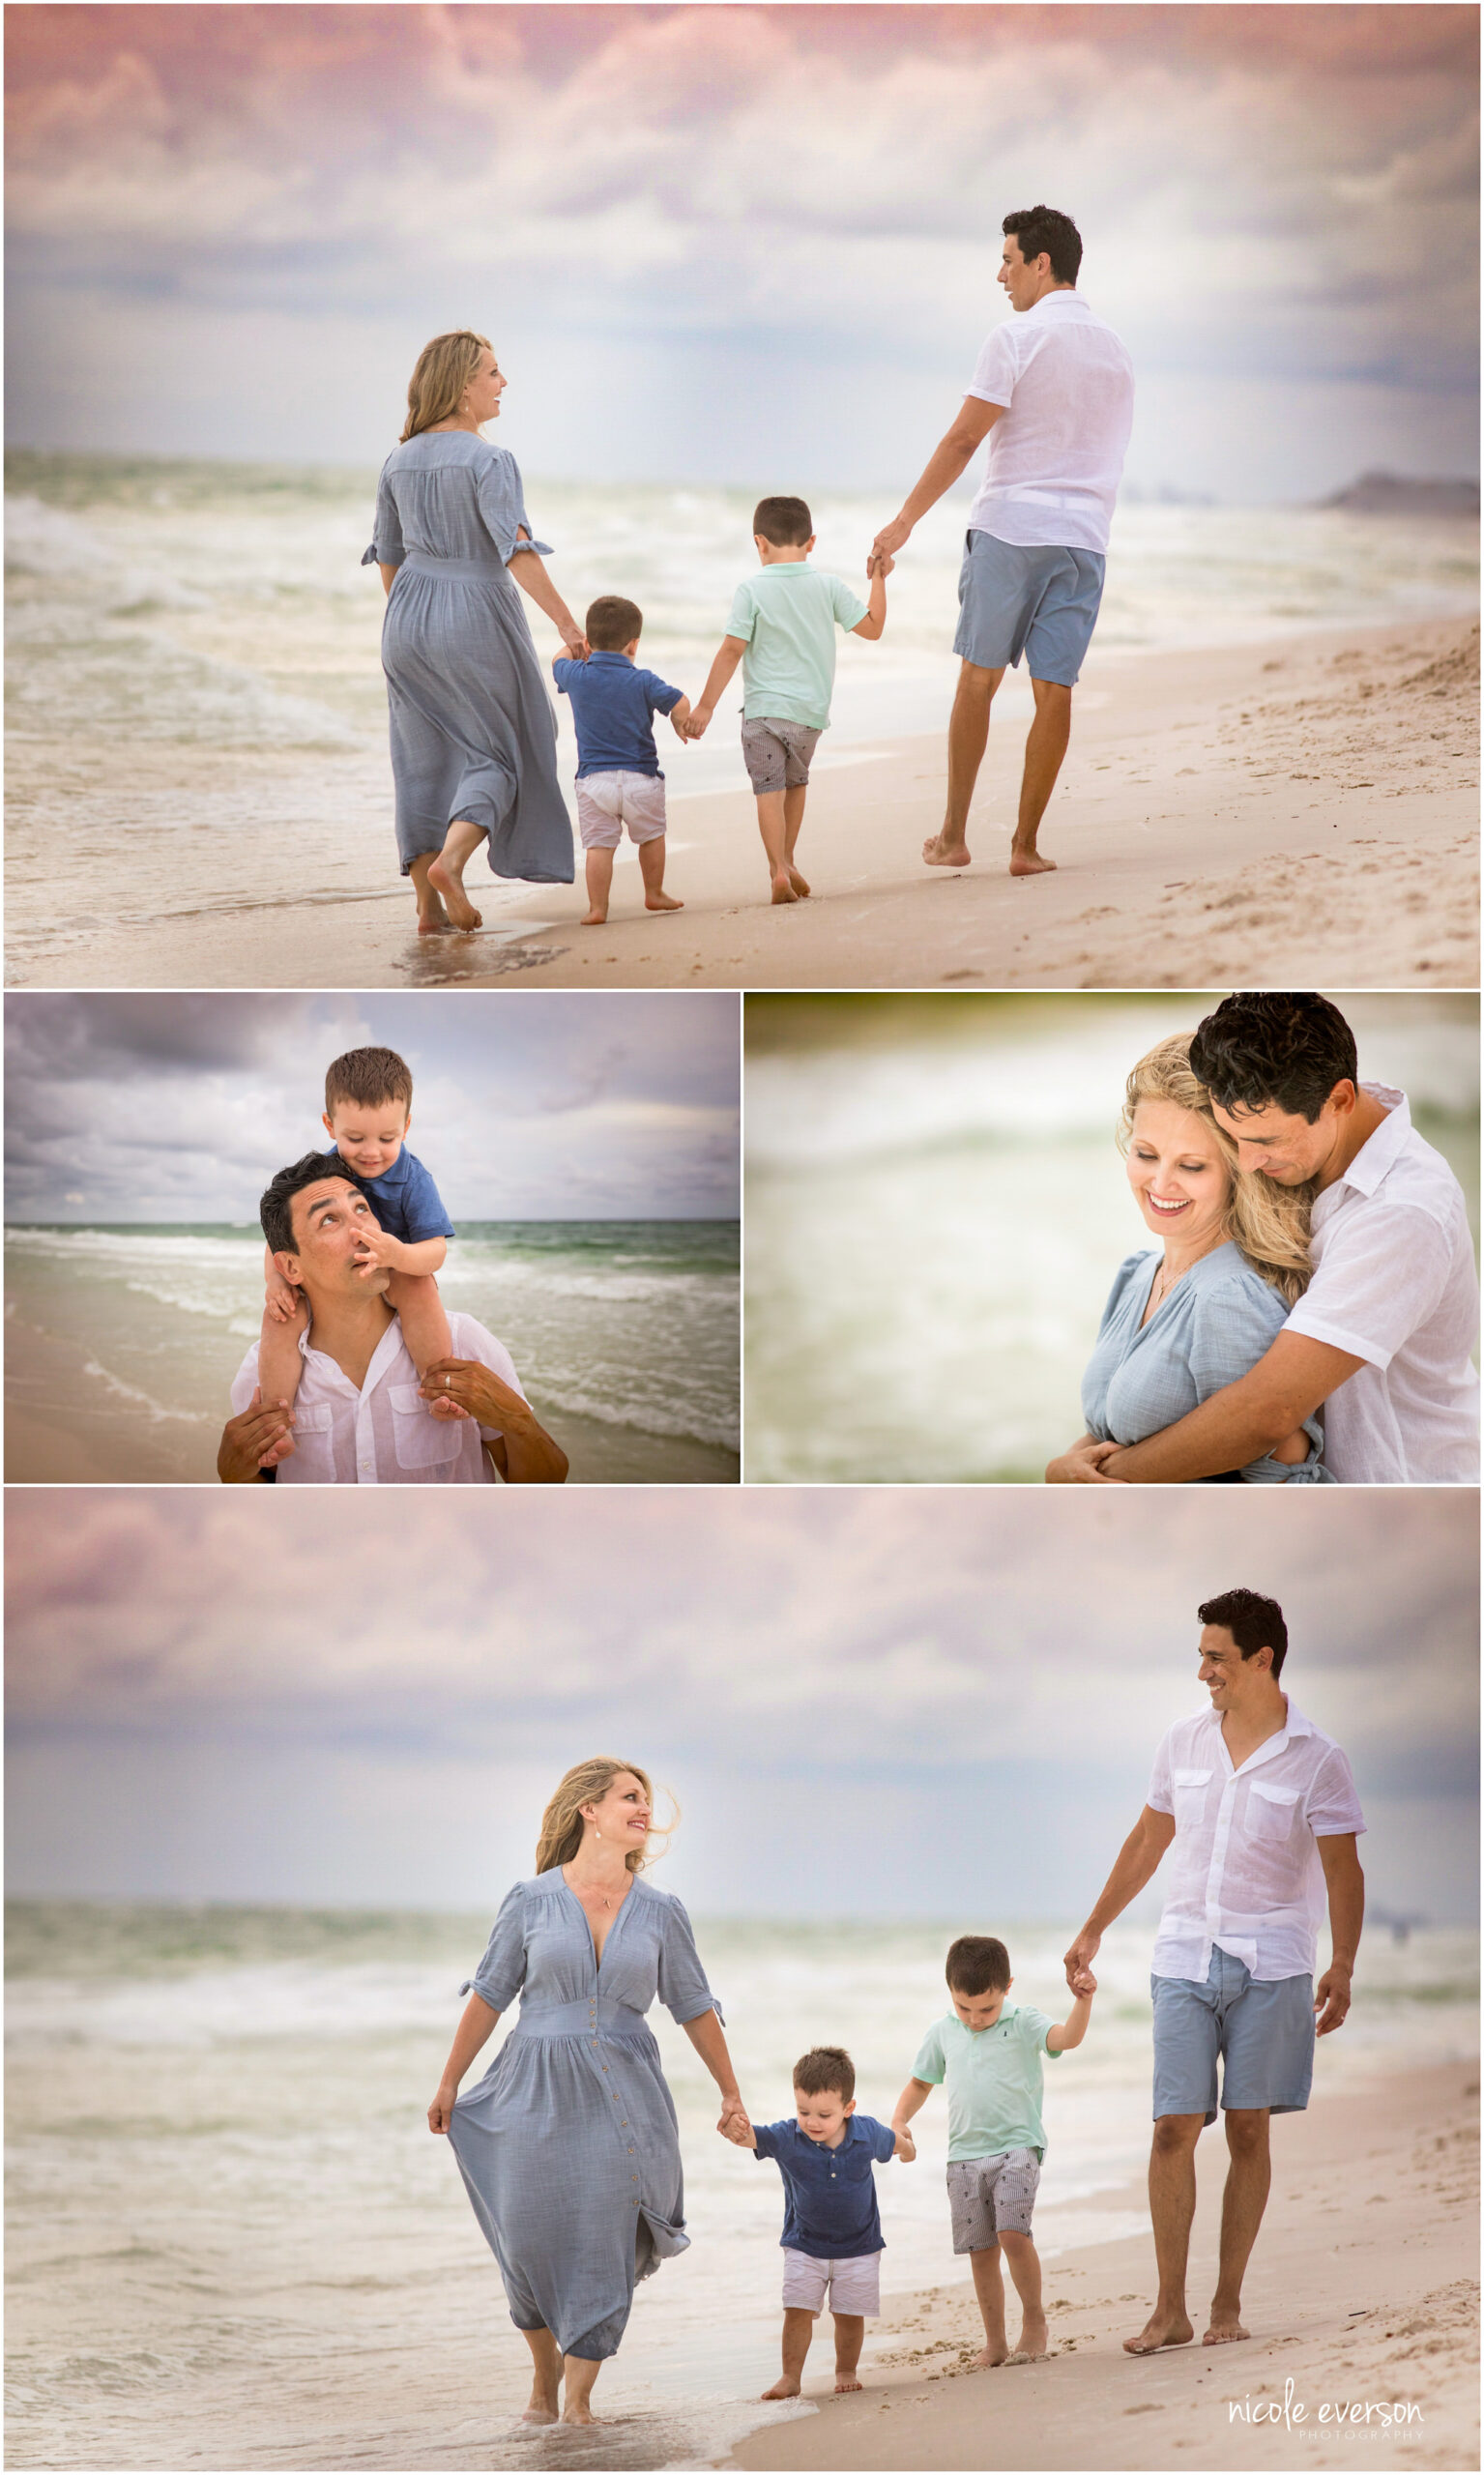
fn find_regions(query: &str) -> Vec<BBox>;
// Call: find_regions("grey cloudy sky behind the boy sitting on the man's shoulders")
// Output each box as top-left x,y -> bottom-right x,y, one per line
5,990 -> 737,1225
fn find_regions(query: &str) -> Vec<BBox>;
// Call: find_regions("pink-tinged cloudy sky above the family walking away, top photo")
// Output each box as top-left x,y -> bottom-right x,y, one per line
8,5 -> 1476,500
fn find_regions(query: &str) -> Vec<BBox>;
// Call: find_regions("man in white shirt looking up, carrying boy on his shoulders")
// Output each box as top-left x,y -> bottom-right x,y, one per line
218,1150 -> 567,1488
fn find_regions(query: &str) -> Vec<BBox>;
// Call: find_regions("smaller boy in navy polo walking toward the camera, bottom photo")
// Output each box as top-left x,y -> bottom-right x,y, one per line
737,2045 -> 917,2399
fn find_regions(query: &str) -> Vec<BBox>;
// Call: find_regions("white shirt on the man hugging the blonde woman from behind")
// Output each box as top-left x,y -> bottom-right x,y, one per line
1284,1084 -> 1479,1488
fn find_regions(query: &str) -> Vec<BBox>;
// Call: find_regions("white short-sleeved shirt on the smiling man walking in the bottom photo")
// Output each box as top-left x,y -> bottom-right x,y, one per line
1148,1696 -> 1365,1985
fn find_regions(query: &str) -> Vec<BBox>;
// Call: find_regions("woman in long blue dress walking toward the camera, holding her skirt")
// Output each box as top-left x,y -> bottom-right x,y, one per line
428,1760 -> 747,2423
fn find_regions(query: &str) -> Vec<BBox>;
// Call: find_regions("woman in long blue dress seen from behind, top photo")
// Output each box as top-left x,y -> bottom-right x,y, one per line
362,332 -> 586,936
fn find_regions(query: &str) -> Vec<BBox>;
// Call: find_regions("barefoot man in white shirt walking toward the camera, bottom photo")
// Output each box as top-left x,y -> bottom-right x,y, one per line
1066,1589 -> 1365,2354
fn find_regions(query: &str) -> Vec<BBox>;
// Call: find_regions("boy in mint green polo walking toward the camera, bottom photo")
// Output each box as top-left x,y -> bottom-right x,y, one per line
893,1933 -> 1098,2366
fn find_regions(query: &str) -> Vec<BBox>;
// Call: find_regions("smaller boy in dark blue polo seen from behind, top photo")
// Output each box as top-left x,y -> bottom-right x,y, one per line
552,594 -> 690,928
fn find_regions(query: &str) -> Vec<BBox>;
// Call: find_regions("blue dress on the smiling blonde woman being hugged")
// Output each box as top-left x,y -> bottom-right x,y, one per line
1081,1240 -> 1333,1488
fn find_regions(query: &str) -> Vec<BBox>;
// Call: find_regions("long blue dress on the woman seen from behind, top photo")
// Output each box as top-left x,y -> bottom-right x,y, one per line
362,430 -> 574,886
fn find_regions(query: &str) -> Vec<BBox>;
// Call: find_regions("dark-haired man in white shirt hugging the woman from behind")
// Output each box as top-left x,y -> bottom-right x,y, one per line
1071,990 -> 1479,1488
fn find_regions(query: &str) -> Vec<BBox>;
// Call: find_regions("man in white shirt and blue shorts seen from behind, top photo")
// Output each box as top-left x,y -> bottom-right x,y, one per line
873,205 -> 1133,876
